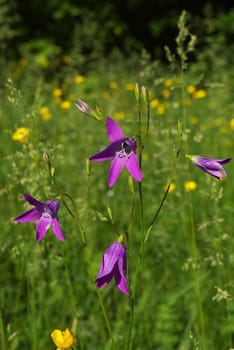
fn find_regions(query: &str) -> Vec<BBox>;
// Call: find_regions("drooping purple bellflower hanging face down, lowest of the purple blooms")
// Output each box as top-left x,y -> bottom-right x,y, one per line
95,242 -> 129,295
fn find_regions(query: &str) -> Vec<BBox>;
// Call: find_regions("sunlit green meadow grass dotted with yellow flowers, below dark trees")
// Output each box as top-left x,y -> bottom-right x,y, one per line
0,12 -> 234,350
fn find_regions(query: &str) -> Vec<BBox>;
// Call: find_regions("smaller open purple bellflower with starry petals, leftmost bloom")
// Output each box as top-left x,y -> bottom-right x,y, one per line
14,194 -> 65,242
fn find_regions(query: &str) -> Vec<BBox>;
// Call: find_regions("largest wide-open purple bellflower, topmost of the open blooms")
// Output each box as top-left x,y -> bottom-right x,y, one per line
89,117 -> 142,187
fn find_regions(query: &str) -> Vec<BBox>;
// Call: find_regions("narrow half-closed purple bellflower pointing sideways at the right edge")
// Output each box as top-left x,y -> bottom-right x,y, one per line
186,154 -> 232,180
